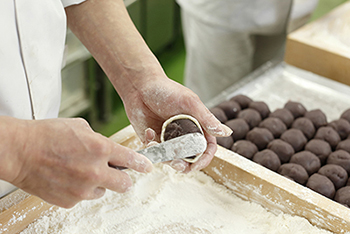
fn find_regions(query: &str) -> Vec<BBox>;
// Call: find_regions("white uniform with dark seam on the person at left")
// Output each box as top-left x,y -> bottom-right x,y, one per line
0,0 -> 84,197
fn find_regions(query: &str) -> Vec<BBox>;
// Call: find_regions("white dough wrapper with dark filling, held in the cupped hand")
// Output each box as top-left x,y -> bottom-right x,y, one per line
160,114 -> 204,163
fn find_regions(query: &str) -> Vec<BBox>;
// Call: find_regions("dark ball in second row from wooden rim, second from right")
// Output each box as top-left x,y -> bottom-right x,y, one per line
289,151 -> 321,175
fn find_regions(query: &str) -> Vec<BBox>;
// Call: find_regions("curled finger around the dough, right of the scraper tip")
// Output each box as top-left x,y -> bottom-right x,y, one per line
190,133 -> 217,171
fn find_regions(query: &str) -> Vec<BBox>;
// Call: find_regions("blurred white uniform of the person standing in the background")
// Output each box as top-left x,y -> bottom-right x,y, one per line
177,0 -> 318,102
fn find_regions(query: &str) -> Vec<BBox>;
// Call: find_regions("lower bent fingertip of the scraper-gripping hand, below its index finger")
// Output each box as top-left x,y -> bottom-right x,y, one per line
101,167 -> 132,193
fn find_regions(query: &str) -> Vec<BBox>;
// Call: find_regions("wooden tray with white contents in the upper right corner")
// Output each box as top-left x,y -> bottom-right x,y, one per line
284,2 -> 350,85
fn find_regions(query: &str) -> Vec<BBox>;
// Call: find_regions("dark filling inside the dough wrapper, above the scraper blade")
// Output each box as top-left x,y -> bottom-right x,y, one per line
164,119 -> 202,141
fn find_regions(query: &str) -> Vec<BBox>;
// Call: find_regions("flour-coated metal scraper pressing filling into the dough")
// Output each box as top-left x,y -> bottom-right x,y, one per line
115,133 -> 207,170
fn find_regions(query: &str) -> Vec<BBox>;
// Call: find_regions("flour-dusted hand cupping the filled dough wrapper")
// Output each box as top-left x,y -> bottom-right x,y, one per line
123,78 -> 232,172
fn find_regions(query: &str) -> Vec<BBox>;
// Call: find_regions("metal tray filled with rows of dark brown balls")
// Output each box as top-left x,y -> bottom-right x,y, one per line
202,62 -> 350,232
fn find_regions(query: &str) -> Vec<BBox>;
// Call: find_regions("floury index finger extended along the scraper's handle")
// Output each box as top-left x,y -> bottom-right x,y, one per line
108,144 -> 153,173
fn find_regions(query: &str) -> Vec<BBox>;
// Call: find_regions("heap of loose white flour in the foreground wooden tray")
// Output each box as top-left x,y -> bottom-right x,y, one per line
22,165 -> 330,234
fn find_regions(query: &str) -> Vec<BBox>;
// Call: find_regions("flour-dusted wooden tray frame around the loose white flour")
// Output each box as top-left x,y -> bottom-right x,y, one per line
0,126 -> 350,233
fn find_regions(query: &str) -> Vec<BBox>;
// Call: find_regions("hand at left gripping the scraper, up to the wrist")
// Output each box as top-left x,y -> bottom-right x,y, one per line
3,118 -> 153,208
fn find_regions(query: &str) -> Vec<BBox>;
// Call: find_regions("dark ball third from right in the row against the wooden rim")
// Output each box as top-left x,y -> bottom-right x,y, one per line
278,163 -> 309,185
